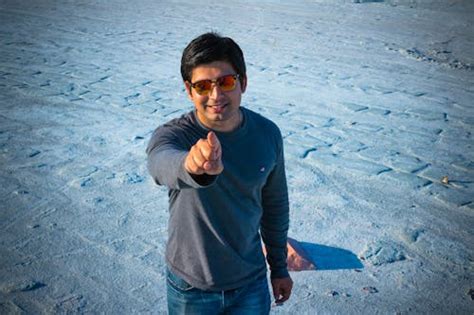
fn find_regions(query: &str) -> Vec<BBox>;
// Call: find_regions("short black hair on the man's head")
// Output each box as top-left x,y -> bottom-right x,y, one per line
181,32 -> 246,84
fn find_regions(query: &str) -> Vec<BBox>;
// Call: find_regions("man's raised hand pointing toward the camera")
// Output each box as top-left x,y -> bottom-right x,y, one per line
184,131 -> 224,175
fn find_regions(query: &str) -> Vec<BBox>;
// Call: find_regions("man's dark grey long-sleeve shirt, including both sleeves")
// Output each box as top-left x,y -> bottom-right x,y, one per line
147,107 -> 289,291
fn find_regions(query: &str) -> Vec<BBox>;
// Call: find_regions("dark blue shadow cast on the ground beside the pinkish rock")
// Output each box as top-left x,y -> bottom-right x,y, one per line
299,242 -> 364,270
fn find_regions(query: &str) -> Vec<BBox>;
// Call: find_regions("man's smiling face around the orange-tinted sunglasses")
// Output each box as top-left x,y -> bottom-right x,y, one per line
185,61 -> 247,132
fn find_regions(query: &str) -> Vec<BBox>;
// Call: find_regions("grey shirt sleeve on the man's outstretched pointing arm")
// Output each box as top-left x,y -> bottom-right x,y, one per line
146,127 -> 217,189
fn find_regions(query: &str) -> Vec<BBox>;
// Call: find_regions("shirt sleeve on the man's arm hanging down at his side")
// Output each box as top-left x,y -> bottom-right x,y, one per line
260,134 -> 289,279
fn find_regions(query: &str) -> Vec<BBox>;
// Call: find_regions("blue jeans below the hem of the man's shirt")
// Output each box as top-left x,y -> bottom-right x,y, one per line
166,270 -> 271,315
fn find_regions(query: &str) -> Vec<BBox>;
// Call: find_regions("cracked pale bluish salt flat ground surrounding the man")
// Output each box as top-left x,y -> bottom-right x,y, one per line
0,0 -> 474,314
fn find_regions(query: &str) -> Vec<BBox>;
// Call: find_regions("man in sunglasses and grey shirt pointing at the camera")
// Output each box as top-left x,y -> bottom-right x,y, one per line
147,33 -> 293,314
